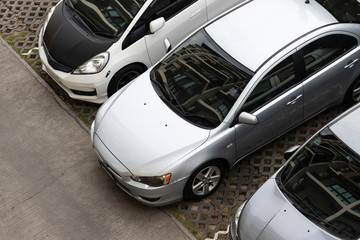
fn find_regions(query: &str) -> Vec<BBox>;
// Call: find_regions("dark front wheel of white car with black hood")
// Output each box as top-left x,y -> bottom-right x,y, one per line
108,64 -> 146,97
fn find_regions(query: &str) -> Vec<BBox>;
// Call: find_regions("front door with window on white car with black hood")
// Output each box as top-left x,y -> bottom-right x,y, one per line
145,0 -> 207,64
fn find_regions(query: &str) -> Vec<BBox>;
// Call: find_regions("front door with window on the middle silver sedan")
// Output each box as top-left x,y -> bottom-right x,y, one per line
235,55 -> 303,158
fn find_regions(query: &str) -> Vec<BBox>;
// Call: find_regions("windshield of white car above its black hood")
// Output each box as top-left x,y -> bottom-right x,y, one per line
67,0 -> 146,37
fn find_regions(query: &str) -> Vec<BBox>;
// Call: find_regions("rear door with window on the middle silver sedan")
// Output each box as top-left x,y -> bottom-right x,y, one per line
299,32 -> 360,118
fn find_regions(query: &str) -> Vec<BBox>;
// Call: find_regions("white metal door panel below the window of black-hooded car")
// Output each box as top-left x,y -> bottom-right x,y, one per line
145,0 -> 207,64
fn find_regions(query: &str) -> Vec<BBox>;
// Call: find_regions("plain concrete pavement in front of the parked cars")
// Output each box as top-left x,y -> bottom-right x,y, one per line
0,39 -> 194,240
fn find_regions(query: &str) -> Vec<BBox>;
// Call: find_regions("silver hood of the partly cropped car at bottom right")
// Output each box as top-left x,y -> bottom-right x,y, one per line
238,178 -> 337,240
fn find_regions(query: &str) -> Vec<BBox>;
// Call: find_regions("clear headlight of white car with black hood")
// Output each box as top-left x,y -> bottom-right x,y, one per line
73,52 -> 109,74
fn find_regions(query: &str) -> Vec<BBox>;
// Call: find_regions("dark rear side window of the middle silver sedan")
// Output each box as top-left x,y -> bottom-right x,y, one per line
302,34 -> 357,76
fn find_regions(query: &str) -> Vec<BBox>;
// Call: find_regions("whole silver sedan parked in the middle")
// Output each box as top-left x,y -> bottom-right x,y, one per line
91,0 -> 360,206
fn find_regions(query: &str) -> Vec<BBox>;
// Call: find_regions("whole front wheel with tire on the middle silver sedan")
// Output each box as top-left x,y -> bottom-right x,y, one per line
184,160 -> 225,200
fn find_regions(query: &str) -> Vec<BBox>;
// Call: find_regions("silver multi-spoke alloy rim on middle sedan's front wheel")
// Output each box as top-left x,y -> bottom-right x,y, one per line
191,166 -> 221,196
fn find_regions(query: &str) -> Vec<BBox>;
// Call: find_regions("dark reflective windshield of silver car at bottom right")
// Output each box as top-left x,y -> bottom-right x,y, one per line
277,128 -> 360,239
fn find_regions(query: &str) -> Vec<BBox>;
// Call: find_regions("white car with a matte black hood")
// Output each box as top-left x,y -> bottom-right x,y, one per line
39,0 -> 242,103
